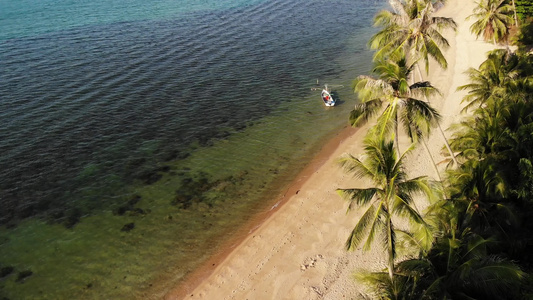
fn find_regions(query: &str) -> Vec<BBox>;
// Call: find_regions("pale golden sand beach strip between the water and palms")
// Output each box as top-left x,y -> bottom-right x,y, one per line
165,0 -> 495,300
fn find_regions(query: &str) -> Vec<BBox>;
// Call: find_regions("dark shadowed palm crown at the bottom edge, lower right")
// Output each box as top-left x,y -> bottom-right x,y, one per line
397,230 -> 526,299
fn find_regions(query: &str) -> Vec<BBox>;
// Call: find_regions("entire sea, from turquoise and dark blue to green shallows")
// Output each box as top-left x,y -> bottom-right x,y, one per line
0,0 -> 386,299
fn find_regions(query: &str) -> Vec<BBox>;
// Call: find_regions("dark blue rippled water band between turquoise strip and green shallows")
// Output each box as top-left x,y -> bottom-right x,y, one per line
0,0 -> 380,220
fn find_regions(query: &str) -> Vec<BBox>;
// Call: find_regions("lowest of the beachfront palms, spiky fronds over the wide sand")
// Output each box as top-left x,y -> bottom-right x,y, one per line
337,137 -> 435,281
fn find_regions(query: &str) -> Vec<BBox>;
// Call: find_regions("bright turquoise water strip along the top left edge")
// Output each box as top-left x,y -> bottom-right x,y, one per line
0,0 -> 264,40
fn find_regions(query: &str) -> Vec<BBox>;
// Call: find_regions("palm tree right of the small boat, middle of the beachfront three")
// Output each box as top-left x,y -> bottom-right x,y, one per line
350,57 -> 440,179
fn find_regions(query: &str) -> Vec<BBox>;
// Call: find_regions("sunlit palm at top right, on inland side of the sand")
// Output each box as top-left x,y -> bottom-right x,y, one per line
467,0 -> 513,44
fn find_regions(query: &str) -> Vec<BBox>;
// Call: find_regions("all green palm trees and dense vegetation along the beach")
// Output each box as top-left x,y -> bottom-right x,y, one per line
339,0 -> 533,299
